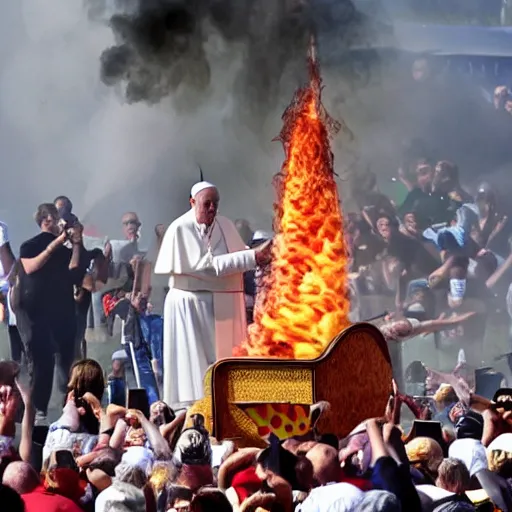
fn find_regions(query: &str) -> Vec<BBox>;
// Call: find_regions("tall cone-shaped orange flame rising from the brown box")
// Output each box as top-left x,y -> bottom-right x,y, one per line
238,41 -> 350,359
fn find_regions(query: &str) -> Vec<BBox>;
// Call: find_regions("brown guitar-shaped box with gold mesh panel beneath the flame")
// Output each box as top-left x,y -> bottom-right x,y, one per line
188,323 -> 392,446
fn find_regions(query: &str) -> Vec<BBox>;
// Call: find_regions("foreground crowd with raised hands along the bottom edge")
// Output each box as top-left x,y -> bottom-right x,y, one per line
0,350 -> 512,512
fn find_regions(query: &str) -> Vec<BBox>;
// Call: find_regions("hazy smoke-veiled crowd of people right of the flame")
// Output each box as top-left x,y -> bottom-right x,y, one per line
346,145 -> 512,368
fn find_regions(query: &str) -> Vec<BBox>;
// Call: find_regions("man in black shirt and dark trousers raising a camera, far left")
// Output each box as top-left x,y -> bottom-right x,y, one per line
13,203 -> 89,425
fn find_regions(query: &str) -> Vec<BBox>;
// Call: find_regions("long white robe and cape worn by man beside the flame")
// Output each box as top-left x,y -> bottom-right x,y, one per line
155,210 -> 256,408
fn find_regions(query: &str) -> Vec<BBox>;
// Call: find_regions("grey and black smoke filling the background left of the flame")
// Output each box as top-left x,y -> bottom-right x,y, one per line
0,0 -> 364,250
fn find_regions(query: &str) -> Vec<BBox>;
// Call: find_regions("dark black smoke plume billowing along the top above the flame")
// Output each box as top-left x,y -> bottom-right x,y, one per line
91,0 -> 364,120
